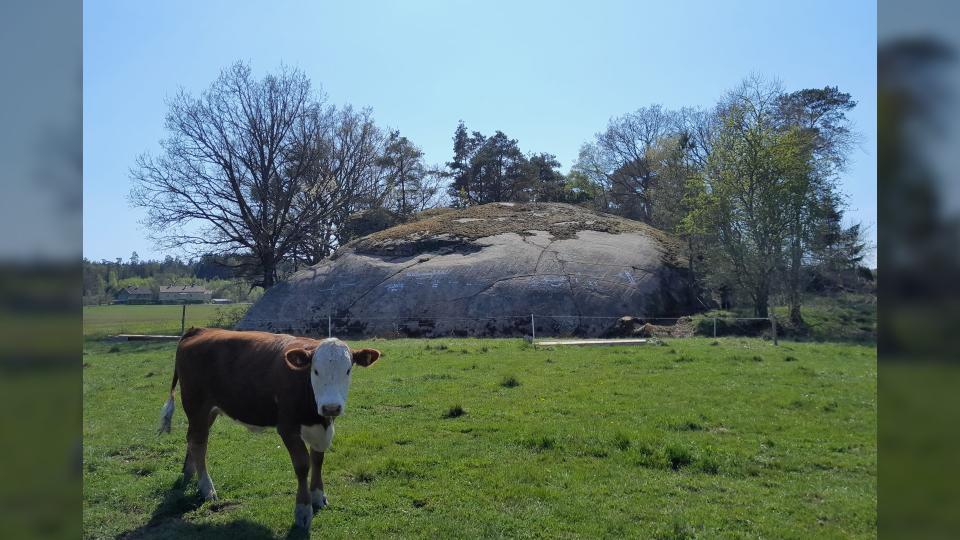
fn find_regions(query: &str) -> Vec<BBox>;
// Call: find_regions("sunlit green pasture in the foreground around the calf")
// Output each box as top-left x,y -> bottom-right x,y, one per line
83,338 -> 877,539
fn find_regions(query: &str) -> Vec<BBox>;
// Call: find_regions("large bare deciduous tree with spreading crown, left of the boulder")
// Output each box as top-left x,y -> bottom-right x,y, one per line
131,62 -> 330,288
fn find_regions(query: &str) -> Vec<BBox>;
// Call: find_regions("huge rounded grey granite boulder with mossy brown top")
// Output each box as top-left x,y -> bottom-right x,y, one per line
238,203 -> 700,337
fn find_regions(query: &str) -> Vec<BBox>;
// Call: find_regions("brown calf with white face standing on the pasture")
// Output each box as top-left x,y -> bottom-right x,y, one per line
160,328 -> 380,528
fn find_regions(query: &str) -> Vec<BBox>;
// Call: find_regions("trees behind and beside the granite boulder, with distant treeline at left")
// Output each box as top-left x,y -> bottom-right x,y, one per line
110,63 -> 875,326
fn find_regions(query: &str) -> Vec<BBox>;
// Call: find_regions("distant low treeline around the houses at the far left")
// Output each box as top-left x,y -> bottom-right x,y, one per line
83,251 -> 263,305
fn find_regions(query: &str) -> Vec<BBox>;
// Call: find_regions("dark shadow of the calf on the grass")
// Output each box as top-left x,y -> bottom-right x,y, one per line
117,480 -> 310,540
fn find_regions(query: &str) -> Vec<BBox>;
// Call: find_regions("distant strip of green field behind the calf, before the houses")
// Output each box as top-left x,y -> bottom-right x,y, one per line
83,304 -> 248,338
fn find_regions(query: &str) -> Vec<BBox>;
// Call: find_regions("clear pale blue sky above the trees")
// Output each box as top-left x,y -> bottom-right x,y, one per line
83,0 -> 877,260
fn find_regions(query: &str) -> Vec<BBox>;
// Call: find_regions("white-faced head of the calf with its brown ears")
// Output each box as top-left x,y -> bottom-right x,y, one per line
284,338 -> 380,416
